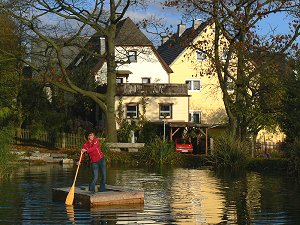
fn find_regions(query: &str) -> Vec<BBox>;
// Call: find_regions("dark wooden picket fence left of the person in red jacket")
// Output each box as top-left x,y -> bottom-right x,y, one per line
15,130 -> 85,148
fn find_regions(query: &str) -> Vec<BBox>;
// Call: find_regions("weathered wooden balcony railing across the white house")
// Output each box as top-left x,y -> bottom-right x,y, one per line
117,83 -> 188,96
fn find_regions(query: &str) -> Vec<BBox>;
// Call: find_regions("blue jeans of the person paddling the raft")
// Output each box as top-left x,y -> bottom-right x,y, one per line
89,157 -> 106,192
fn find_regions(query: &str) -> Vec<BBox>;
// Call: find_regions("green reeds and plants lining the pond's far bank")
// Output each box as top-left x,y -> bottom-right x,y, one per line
4,129 -> 300,177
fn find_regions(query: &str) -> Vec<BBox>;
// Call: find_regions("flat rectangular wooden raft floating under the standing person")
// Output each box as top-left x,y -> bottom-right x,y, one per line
52,185 -> 144,206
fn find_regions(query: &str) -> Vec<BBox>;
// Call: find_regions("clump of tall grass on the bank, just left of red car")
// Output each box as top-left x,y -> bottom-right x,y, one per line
140,137 -> 180,165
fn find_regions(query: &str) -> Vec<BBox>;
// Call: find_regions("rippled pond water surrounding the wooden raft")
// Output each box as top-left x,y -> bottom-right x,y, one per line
0,164 -> 300,225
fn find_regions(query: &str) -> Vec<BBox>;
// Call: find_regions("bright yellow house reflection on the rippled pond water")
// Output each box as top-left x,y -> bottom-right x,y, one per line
170,169 -> 225,224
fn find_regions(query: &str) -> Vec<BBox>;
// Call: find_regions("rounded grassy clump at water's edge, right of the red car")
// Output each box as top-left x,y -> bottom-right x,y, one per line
211,134 -> 251,169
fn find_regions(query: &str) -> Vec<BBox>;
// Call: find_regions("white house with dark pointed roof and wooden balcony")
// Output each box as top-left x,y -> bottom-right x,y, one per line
69,18 -> 189,131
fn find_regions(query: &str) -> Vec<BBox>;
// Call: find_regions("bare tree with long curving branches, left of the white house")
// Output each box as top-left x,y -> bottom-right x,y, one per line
0,0 -> 145,141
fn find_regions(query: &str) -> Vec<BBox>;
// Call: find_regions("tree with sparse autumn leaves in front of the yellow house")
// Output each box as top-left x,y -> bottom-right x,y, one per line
166,0 -> 300,140
